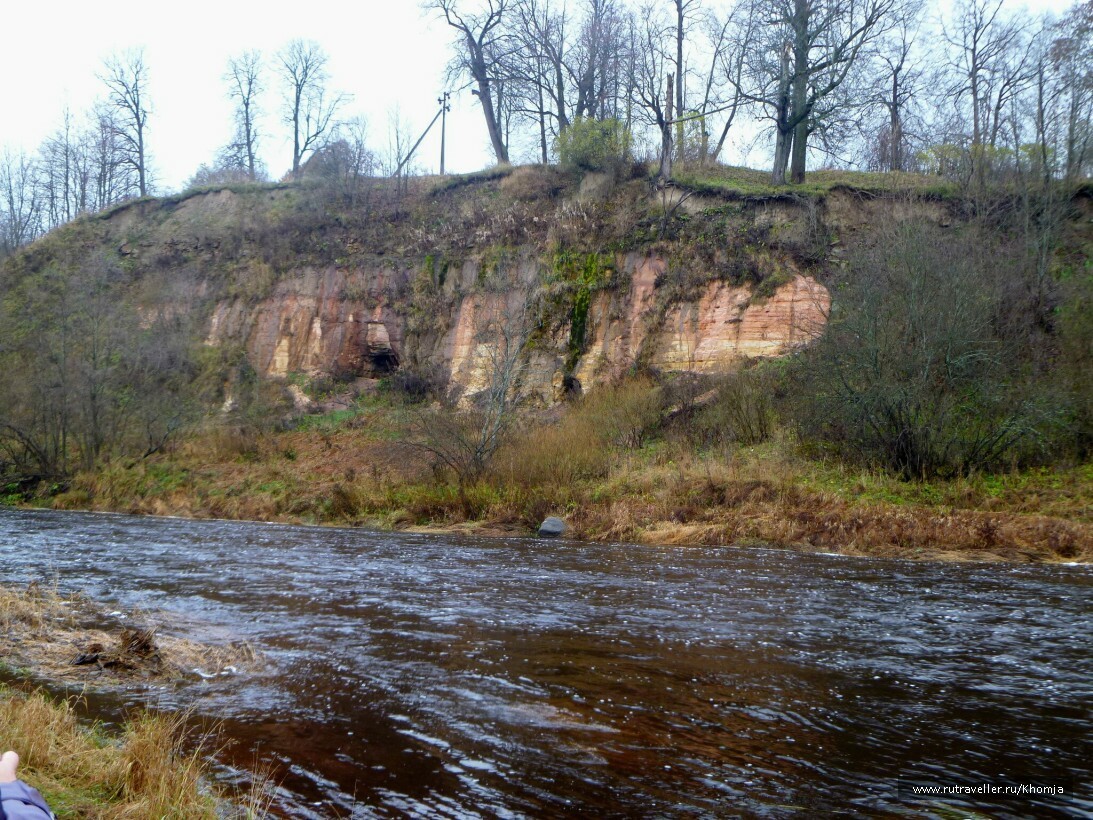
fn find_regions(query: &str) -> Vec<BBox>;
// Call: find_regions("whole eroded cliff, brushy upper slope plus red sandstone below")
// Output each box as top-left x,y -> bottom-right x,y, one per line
7,171 -> 966,403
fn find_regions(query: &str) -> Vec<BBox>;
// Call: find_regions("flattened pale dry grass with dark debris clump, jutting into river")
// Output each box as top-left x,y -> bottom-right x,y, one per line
0,583 -> 262,688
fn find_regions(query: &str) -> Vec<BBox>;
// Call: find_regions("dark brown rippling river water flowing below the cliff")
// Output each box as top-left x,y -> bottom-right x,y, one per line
0,511 -> 1093,818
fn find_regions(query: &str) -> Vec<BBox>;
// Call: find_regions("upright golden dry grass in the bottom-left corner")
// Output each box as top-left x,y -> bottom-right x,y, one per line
0,687 -> 269,820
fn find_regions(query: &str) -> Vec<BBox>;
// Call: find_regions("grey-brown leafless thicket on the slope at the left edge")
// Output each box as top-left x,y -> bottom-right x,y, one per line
0,254 -> 196,482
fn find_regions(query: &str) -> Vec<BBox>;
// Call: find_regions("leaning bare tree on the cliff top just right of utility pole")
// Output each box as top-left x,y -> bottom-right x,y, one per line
423,0 -> 509,165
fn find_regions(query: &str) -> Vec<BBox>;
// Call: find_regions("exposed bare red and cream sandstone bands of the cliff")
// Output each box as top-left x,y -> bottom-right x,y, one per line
205,254 -> 831,401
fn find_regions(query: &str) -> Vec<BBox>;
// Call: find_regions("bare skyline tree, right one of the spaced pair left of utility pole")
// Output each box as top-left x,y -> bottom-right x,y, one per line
277,39 -> 348,177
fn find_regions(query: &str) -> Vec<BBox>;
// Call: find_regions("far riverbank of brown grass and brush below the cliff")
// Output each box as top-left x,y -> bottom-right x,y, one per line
19,400 -> 1093,563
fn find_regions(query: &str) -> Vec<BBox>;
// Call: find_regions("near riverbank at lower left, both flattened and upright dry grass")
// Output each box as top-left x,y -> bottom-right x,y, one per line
0,583 -> 268,820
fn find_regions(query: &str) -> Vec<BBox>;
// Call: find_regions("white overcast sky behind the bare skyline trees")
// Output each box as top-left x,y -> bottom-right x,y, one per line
0,0 -> 1071,190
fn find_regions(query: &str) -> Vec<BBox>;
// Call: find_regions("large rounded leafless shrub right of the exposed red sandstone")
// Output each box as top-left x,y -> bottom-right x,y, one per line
795,223 -> 1060,478
